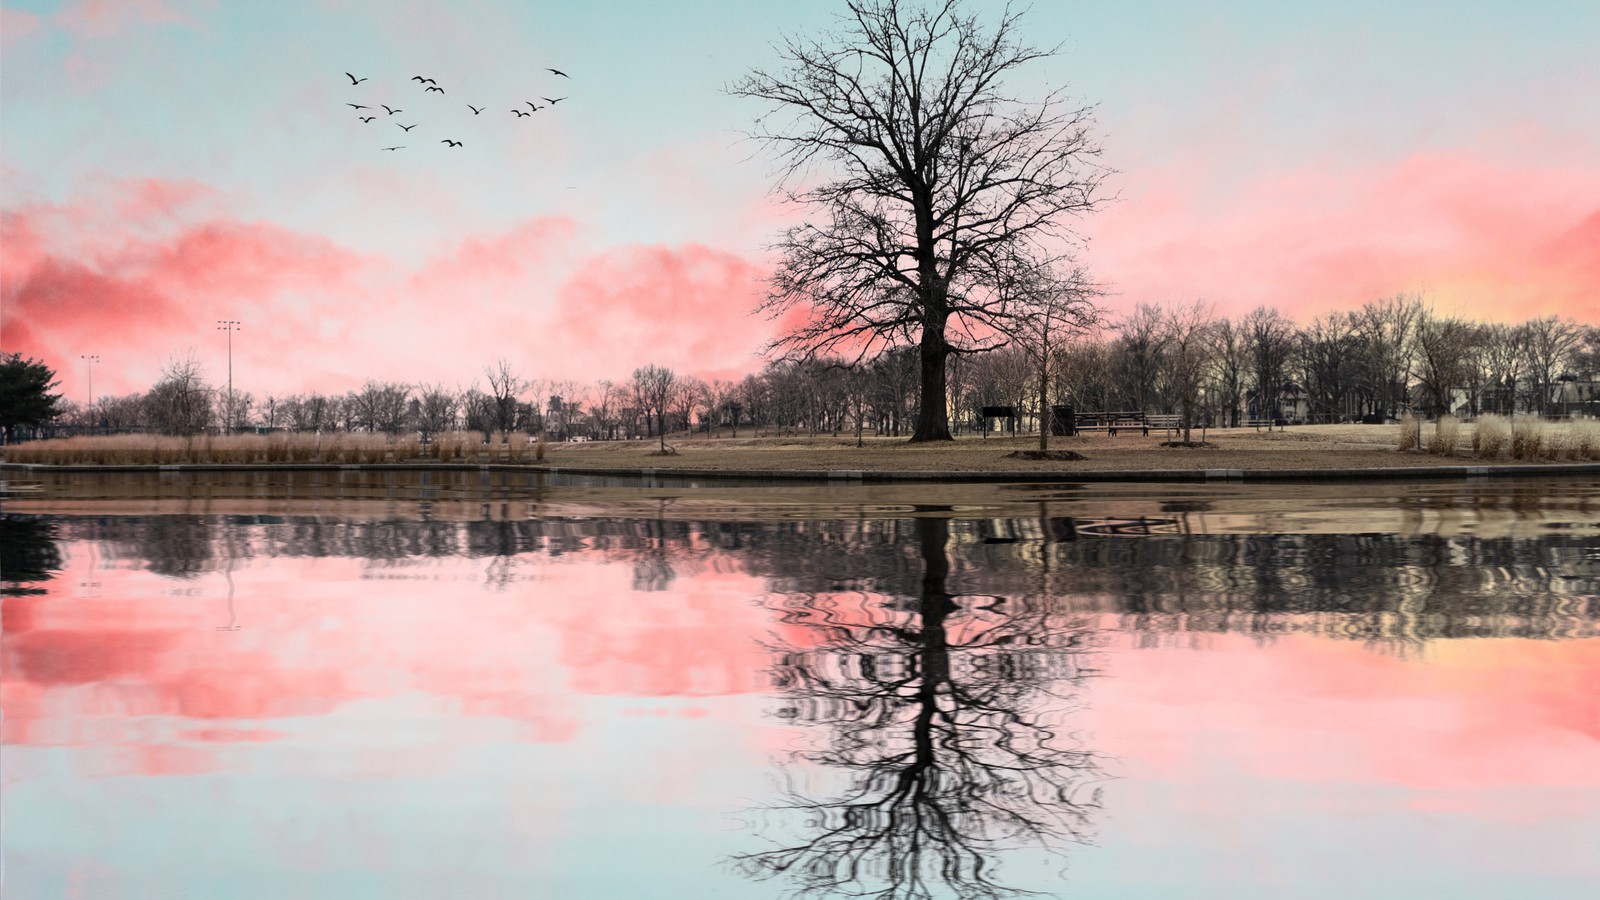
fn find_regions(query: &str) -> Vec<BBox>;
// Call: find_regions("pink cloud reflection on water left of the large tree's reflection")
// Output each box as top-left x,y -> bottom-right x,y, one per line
0,544 -> 765,773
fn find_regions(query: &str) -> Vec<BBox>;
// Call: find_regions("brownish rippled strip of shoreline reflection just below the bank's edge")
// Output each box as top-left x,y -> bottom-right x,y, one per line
8,471 -> 1600,538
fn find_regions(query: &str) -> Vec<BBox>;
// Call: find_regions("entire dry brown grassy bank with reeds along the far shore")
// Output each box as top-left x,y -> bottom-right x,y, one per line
5,420 -> 1600,472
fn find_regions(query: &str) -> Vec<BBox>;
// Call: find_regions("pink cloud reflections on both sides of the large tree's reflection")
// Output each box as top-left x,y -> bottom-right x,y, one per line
0,544 -> 1600,806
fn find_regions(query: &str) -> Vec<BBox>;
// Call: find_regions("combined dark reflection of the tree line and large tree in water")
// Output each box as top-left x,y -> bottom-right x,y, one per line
12,514 -> 1600,898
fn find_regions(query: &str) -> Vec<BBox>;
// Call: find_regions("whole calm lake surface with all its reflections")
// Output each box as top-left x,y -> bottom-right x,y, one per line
0,472 -> 1600,900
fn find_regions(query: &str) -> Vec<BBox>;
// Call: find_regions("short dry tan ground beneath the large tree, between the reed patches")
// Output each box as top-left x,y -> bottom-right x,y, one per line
546,424 -> 1574,474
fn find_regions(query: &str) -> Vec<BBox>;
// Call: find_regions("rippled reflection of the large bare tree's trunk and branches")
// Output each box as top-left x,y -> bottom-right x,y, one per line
736,517 -> 1094,900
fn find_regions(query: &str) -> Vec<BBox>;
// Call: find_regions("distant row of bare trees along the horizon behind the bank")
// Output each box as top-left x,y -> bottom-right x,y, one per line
18,296 -> 1600,448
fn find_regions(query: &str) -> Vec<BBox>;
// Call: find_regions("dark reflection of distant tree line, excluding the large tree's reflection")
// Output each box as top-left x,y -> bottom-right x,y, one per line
25,516 -> 1600,641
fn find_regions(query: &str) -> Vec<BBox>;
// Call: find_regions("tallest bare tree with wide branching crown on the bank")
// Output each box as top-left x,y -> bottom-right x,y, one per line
731,0 -> 1104,442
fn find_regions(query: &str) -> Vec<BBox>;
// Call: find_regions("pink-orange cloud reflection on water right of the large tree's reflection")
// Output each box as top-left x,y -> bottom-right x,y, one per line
1086,624 -> 1600,797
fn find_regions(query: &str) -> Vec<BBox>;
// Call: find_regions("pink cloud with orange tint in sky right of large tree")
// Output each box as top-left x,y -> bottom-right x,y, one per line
1086,152 -> 1600,320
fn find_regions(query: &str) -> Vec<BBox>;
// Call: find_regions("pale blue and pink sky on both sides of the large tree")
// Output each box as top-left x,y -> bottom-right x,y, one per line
0,0 -> 1600,400
